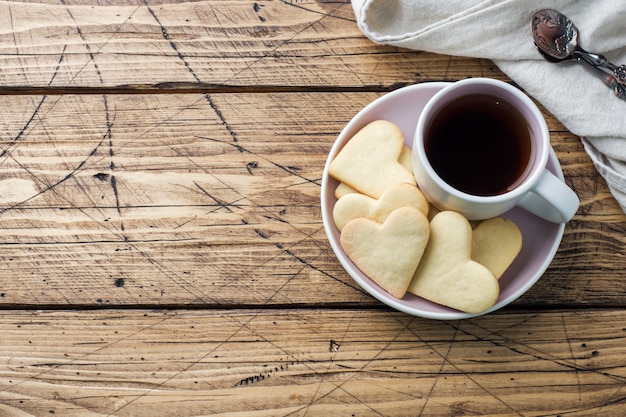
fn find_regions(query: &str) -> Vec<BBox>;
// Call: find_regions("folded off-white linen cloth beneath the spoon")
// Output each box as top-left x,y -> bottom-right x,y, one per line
352,0 -> 626,211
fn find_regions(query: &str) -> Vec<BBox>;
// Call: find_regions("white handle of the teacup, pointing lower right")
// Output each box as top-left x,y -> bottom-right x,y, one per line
517,169 -> 580,223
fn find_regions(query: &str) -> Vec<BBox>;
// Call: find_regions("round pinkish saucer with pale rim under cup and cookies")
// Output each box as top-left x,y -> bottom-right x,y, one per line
321,82 -> 565,320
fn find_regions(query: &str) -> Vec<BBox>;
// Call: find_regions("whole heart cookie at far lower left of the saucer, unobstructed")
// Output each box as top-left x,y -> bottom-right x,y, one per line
340,207 -> 429,298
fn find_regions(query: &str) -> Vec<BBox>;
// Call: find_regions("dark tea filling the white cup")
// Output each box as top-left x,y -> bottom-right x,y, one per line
424,94 -> 532,196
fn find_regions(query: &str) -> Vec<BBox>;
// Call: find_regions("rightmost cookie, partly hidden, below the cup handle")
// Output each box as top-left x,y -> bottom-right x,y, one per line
472,217 -> 522,279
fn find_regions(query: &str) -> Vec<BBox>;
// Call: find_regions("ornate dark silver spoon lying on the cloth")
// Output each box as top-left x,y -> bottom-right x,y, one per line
530,9 -> 626,100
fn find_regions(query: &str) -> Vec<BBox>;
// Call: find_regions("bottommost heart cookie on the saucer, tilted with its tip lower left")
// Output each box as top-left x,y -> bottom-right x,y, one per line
408,211 -> 500,314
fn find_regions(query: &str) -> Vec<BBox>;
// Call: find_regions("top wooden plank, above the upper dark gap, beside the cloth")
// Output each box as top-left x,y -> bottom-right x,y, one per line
0,0 -> 504,92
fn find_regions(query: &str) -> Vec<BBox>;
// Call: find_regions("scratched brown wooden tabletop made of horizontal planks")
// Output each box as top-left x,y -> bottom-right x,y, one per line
0,0 -> 626,417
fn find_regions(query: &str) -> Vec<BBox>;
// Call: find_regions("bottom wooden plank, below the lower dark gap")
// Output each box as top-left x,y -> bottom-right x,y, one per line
0,310 -> 626,417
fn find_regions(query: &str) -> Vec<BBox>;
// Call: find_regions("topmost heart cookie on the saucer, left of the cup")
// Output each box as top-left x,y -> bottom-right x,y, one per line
328,120 -> 416,198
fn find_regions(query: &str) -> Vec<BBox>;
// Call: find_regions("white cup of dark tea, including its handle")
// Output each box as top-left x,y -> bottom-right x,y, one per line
413,78 -> 579,223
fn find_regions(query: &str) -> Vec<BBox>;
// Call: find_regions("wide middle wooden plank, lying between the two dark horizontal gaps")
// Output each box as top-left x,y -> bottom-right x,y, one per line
0,93 -> 626,306
